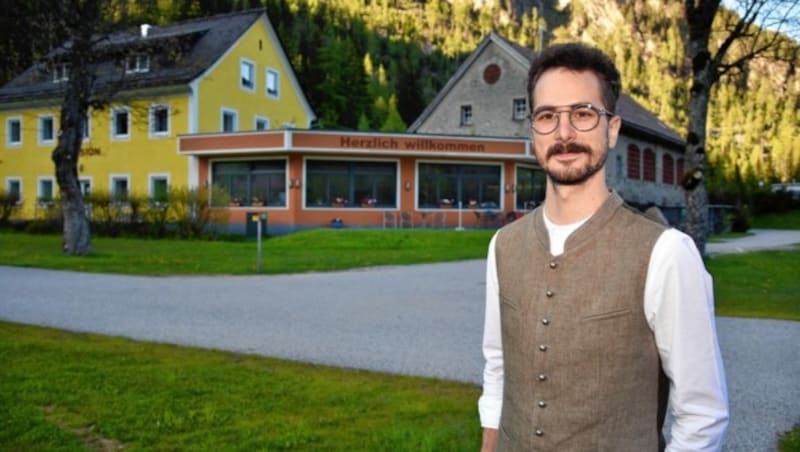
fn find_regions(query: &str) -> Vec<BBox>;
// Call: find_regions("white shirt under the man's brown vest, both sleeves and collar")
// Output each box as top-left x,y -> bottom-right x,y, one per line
478,216 -> 728,452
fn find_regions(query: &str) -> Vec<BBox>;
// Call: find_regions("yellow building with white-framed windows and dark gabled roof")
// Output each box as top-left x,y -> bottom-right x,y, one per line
0,10 -> 316,218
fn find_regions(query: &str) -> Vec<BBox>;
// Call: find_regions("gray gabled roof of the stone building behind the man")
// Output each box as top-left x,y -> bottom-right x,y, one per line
408,32 -> 685,152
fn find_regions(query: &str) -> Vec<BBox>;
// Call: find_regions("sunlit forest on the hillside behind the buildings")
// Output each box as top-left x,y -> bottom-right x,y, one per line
0,0 -> 800,200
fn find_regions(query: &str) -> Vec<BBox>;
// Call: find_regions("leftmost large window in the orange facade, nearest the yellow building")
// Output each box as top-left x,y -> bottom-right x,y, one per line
211,160 -> 286,207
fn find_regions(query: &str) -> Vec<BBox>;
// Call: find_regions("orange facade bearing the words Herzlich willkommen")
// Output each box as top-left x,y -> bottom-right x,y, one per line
178,130 -> 536,232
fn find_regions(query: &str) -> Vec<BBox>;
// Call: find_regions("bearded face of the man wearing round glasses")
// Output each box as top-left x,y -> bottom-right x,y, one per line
533,68 -> 621,185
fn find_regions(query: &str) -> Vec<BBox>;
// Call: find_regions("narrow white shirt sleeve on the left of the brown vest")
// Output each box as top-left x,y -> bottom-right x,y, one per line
478,234 -> 503,429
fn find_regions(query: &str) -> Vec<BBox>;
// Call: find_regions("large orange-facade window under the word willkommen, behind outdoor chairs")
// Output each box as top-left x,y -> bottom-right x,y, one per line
417,163 -> 501,209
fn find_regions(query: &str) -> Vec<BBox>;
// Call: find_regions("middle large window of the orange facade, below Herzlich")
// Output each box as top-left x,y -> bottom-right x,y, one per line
306,160 -> 397,207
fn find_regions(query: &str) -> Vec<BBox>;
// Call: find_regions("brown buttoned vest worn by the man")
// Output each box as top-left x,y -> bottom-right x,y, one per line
495,193 -> 666,452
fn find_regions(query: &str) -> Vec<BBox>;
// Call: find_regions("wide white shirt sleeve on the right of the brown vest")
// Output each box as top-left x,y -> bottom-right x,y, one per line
644,229 -> 728,452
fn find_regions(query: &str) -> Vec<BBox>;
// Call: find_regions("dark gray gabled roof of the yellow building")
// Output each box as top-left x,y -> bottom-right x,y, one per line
0,10 -> 265,103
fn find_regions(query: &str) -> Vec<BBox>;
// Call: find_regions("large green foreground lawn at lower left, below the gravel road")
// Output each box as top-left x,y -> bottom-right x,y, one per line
0,322 -> 480,451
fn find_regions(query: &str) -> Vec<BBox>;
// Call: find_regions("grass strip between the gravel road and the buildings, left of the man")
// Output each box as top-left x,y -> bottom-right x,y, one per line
0,229 -> 494,275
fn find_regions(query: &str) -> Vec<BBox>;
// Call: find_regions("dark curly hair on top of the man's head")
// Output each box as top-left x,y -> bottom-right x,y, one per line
528,43 -> 622,112
